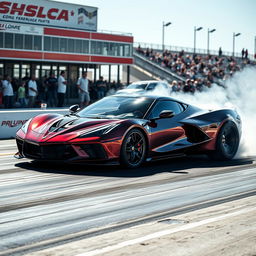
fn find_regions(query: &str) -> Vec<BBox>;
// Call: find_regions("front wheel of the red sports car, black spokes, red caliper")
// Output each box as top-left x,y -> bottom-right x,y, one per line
120,129 -> 147,168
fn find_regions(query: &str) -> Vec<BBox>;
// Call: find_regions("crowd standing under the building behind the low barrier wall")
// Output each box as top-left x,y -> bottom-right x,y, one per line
0,71 -> 123,108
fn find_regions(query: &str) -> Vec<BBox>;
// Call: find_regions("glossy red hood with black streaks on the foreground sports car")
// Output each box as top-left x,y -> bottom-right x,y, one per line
26,115 -> 124,142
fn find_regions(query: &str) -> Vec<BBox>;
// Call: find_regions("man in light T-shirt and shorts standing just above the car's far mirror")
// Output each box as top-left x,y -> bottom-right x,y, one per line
77,72 -> 90,108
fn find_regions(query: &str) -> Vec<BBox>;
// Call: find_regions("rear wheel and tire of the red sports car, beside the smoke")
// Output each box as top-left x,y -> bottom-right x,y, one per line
208,122 -> 239,160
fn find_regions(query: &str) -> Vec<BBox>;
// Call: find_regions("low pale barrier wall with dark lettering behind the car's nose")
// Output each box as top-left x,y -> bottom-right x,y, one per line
0,109 -> 69,139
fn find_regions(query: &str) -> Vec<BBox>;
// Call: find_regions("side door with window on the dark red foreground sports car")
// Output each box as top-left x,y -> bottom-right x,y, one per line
148,100 -> 186,153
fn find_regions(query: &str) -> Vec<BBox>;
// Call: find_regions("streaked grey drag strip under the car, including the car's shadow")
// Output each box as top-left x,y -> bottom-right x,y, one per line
0,140 -> 256,255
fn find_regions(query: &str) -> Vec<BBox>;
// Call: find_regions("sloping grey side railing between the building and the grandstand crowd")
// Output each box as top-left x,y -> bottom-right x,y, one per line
133,52 -> 185,82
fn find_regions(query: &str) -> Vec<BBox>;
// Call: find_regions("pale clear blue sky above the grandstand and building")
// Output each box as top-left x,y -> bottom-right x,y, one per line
57,0 -> 256,54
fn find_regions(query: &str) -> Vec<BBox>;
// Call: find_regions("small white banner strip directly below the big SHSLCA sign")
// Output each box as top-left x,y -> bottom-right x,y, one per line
0,21 -> 44,35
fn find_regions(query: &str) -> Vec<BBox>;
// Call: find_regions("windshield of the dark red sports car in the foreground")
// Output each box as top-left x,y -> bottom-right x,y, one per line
77,96 -> 154,119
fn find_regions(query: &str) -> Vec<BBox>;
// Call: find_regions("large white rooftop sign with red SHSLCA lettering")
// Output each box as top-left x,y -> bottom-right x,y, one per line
0,0 -> 98,31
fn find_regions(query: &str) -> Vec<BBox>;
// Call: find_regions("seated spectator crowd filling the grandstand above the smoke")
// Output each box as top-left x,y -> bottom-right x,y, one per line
136,46 -> 256,93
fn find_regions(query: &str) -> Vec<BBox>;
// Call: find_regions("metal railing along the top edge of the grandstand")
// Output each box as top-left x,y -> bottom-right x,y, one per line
133,42 -> 254,60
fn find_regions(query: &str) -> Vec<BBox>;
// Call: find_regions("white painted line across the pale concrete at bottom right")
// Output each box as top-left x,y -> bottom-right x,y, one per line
76,207 -> 256,256
